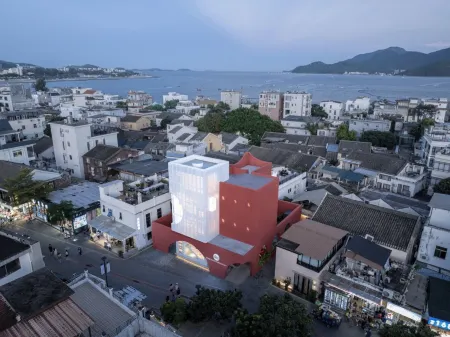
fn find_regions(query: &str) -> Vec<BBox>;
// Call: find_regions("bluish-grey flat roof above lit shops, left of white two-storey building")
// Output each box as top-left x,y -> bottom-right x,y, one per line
48,181 -> 100,207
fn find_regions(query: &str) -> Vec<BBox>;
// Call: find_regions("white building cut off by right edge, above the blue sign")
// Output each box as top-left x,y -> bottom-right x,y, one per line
417,193 -> 450,276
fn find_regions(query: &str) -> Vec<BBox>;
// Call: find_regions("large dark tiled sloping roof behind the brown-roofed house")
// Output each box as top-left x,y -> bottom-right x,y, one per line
312,195 -> 420,251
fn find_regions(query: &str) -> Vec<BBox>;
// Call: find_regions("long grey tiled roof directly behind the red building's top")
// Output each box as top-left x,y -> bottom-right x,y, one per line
248,146 -> 319,172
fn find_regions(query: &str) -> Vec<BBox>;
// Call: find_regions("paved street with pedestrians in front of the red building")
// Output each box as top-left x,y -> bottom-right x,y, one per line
8,220 -> 376,337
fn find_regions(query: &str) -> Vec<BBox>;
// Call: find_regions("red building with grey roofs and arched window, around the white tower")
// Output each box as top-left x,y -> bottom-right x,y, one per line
152,153 -> 301,278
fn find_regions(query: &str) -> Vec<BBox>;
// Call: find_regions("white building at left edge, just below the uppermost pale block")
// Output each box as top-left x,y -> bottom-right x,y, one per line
0,110 -> 47,139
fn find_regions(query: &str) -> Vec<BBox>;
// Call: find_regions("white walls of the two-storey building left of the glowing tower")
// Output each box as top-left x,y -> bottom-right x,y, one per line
99,180 -> 171,249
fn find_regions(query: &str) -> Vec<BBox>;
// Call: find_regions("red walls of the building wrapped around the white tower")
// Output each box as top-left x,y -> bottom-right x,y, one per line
152,153 -> 301,278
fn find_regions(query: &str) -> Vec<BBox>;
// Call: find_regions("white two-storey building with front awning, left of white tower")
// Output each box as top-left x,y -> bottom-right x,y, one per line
89,179 -> 171,252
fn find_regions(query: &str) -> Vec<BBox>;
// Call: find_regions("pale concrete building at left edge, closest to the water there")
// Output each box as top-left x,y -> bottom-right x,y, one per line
0,84 -> 34,112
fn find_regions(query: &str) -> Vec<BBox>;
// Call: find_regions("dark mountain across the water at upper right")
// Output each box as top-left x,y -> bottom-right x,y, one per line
292,47 -> 450,76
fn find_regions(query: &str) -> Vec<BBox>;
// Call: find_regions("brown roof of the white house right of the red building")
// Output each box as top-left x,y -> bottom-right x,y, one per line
281,219 -> 348,260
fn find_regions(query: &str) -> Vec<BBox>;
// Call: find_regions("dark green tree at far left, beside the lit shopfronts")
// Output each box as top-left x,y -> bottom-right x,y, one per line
5,168 -> 51,206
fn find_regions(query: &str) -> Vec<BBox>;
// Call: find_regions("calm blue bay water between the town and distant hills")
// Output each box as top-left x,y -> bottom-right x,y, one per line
48,71 -> 450,102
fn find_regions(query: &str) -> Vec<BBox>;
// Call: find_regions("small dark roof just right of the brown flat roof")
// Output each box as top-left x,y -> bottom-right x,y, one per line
346,235 -> 392,267
